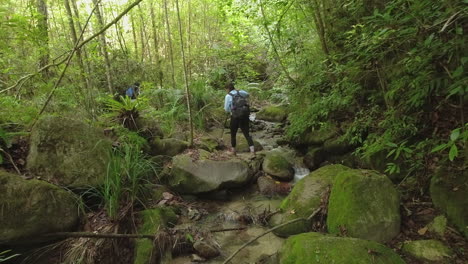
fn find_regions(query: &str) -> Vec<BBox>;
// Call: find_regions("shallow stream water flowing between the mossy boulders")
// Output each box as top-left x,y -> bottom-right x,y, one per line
171,114 -> 309,264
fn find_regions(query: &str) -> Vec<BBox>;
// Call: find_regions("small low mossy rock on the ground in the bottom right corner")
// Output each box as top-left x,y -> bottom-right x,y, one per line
402,240 -> 453,263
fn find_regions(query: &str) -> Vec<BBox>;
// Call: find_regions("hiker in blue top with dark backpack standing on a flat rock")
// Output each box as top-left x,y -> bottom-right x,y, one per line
224,83 -> 255,155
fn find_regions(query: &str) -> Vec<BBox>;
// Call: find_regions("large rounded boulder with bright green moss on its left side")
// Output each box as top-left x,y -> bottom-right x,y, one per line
327,170 -> 400,242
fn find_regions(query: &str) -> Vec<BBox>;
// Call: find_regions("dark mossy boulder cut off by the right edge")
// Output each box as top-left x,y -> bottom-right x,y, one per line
430,168 -> 468,238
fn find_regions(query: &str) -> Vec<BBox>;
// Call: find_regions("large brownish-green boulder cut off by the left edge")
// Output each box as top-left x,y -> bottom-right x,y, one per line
0,170 -> 79,245
